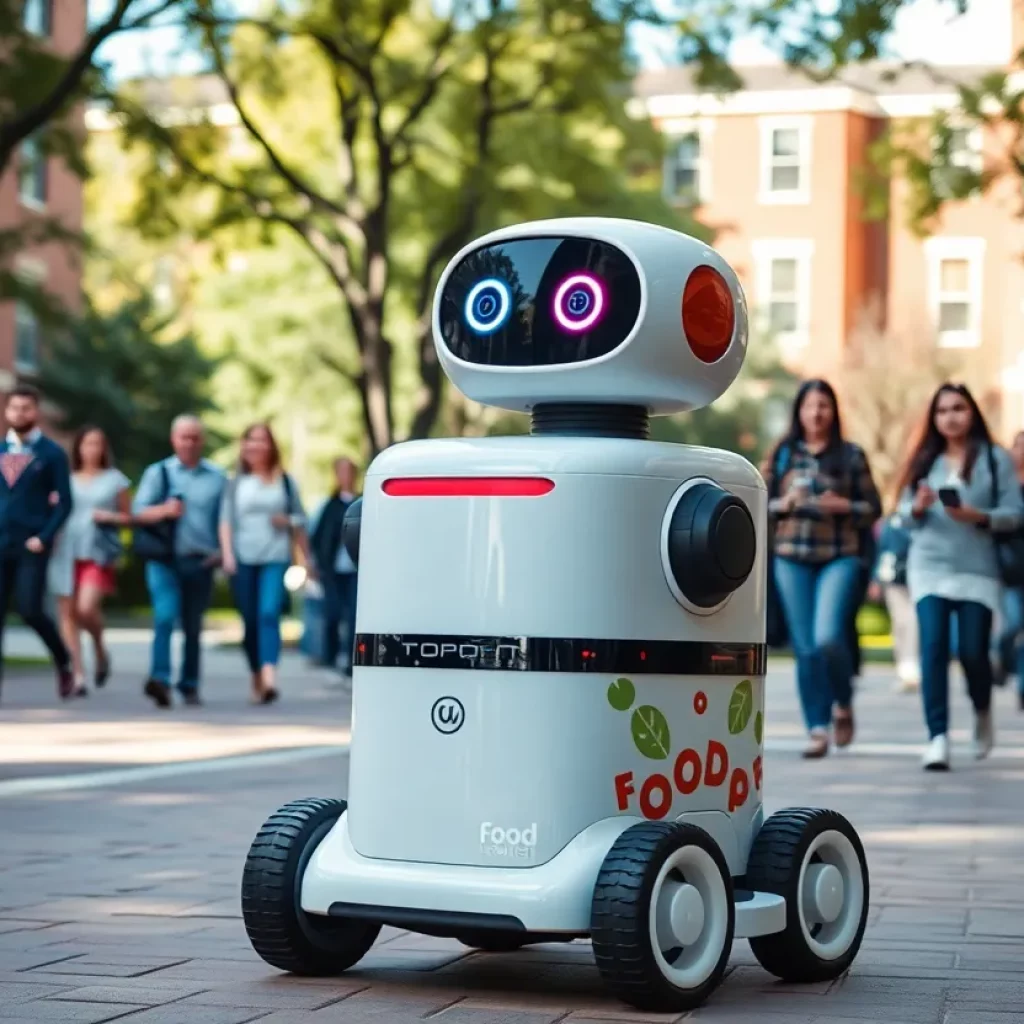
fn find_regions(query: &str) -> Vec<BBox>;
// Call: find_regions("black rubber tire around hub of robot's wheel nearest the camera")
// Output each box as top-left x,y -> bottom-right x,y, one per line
591,821 -> 736,1013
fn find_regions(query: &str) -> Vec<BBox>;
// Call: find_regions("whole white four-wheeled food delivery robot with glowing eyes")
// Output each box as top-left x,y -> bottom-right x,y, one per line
242,218 -> 868,1012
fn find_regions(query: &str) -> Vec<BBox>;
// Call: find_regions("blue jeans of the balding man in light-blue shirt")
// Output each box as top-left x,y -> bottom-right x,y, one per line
145,558 -> 213,693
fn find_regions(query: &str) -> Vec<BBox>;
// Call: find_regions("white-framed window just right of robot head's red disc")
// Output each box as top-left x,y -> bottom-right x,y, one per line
754,239 -> 814,350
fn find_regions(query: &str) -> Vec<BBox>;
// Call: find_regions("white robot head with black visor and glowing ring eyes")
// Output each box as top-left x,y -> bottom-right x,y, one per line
433,217 -> 746,414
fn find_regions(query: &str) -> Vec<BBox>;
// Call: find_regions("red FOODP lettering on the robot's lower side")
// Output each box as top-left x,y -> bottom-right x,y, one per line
614,739 -> 761,821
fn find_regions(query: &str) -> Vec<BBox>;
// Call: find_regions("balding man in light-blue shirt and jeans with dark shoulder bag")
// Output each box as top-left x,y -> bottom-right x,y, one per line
132,416 -> 225,708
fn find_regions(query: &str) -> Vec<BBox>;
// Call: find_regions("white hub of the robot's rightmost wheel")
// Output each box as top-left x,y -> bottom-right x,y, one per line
797,830 -> 865,961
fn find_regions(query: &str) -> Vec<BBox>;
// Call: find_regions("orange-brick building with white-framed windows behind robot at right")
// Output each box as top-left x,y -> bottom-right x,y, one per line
634,0 -> 1024,434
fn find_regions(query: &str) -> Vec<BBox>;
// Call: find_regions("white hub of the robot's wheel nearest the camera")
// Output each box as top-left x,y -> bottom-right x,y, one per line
650,846 -> 729,989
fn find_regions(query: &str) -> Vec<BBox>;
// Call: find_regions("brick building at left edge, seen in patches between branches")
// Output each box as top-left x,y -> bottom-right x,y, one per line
0,0 -> 86,391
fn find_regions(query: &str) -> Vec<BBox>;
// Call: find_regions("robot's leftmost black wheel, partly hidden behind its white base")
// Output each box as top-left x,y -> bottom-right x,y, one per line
242,797 -> 381,976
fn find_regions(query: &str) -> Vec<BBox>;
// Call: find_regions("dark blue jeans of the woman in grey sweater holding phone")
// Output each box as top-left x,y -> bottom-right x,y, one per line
918,597 -> 992,739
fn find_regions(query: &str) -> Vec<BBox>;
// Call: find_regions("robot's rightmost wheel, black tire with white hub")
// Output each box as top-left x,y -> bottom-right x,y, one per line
746,808 -> 870,982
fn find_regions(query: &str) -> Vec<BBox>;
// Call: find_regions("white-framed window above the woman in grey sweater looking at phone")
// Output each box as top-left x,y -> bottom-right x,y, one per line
925,238 -> 985,348
